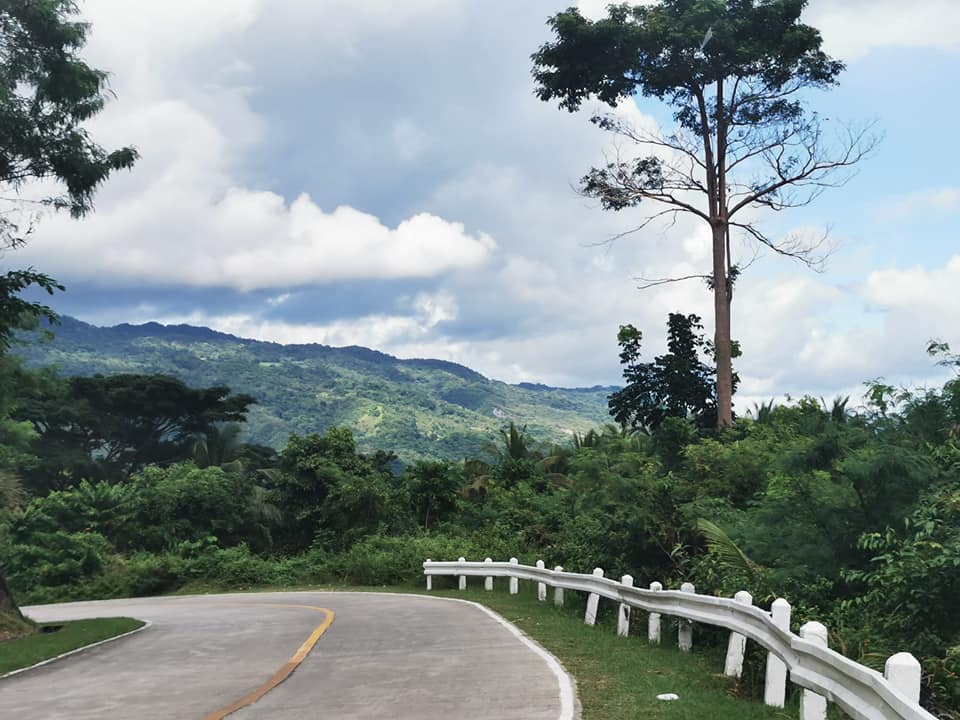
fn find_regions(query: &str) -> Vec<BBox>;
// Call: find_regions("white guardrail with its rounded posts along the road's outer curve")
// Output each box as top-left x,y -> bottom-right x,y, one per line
423,558 -> 936,720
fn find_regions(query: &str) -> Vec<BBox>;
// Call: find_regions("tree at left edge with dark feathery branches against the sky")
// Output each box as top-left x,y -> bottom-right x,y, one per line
0,0 -> 137,615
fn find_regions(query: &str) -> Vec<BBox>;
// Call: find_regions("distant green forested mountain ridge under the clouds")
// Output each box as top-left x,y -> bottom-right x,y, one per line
16,317 -> 616,461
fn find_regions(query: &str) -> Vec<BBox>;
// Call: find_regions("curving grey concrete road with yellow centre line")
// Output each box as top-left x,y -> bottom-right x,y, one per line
0,593 -> 575,720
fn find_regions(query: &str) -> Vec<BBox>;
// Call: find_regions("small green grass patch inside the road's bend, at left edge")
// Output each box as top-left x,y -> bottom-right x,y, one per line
0,618 -> 143,675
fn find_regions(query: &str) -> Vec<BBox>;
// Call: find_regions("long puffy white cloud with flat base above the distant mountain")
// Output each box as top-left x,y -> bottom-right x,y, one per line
19,186 -> 495,290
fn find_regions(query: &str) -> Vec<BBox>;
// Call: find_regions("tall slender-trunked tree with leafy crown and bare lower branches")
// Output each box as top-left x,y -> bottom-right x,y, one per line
533,0 -> 876,427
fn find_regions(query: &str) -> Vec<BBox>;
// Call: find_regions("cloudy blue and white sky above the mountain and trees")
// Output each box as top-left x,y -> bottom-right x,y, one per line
11,0 -> 960,408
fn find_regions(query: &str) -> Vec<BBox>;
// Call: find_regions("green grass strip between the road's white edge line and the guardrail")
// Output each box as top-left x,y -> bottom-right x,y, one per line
421,578 -> 798,720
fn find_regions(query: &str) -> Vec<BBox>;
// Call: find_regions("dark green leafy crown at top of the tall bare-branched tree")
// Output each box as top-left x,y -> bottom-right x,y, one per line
533,0 -> 843,115
